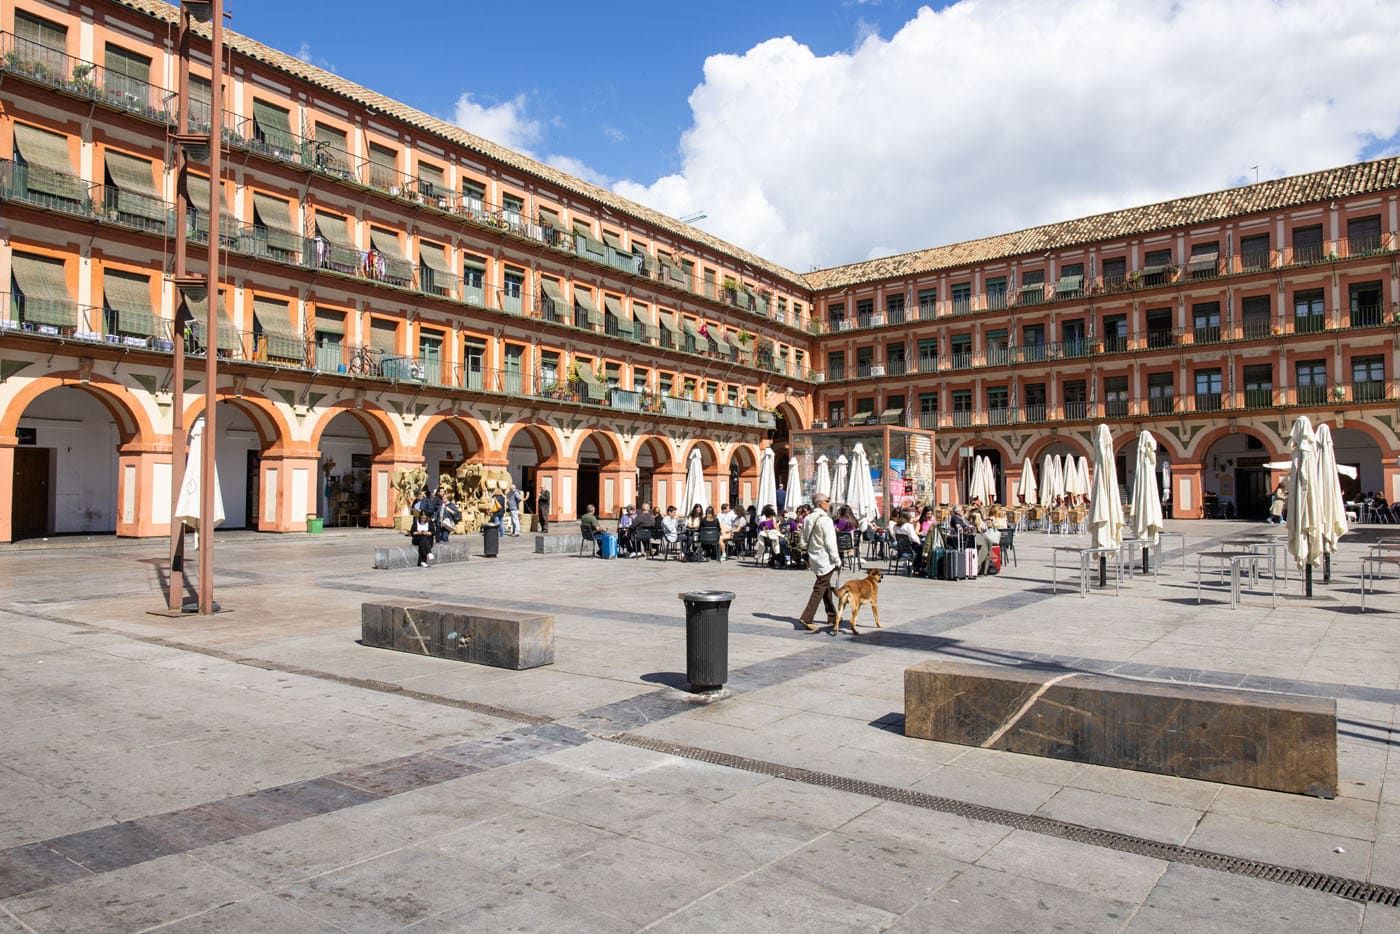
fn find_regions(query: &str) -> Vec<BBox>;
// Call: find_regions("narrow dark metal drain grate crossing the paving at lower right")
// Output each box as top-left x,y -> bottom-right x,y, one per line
610,732 -> 1400,906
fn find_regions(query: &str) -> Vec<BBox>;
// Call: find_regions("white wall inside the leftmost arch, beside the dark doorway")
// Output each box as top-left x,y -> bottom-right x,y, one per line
17,389 -> 119,534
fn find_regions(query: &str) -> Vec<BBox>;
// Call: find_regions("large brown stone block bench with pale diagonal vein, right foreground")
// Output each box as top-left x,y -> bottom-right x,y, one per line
904,661 -> 1337,798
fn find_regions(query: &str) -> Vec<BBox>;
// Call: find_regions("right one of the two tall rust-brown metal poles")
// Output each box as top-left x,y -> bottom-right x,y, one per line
199,0 -> 224,616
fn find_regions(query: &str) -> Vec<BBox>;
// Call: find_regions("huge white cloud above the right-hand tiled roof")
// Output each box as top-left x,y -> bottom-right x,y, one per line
615,0 -> 1400,270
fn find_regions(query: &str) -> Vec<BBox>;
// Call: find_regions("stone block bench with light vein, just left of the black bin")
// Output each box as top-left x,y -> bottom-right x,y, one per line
360,601 -> 554,669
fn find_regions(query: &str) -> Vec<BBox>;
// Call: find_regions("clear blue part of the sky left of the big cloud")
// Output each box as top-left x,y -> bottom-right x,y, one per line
228,0 -> 938,182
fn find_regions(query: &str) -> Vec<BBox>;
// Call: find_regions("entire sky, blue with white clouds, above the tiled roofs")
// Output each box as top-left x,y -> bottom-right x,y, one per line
228,0 -> 1400,272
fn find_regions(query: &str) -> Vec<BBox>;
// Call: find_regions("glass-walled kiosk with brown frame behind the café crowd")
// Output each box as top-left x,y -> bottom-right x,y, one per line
792,424 -> 934,515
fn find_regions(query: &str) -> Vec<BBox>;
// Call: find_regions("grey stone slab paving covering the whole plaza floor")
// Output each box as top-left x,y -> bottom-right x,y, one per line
0,522 -> 1400,934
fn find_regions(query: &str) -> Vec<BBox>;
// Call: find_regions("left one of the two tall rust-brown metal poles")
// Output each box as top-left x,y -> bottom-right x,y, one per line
165,4 -> 192,612
